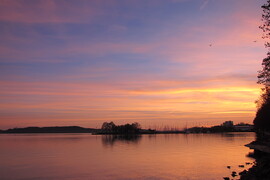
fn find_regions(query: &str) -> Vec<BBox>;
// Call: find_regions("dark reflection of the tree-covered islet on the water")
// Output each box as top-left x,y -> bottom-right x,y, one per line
101,134 -> 142,146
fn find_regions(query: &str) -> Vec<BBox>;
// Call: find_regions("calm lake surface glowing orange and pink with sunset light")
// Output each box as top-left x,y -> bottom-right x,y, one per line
0,133 -> 254,180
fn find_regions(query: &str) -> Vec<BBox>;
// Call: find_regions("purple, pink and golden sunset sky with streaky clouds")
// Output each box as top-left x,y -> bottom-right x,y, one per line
0,0 -> 266,129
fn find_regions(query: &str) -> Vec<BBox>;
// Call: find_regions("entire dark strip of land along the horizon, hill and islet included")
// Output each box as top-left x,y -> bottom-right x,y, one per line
0,121 -> 254,135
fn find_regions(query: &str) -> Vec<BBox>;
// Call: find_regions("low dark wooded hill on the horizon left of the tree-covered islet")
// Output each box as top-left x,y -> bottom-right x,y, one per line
0,126 -> 97,133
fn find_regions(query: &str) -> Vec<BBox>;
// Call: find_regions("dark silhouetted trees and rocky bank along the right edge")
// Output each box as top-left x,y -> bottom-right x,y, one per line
234,0 -> 270,180
